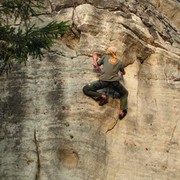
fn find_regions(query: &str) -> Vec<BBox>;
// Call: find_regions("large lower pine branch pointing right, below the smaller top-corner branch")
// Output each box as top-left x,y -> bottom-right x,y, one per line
0,21 -> 68,72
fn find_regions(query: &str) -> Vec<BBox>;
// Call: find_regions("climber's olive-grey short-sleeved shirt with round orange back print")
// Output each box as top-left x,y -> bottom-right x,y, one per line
97,55 -> 124,81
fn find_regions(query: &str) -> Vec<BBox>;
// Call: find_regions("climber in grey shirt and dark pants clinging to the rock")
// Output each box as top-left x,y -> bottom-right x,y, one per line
83,47 -> 128,120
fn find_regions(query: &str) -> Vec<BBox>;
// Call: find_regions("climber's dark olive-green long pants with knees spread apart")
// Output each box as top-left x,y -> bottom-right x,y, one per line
83,80 -> 128,110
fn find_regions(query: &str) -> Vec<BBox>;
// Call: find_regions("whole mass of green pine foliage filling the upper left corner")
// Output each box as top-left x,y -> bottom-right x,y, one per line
0,0 -> 68,73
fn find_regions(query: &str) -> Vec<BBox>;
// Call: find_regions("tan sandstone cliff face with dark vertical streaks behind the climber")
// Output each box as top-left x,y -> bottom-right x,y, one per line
0,0 -> 180,180
